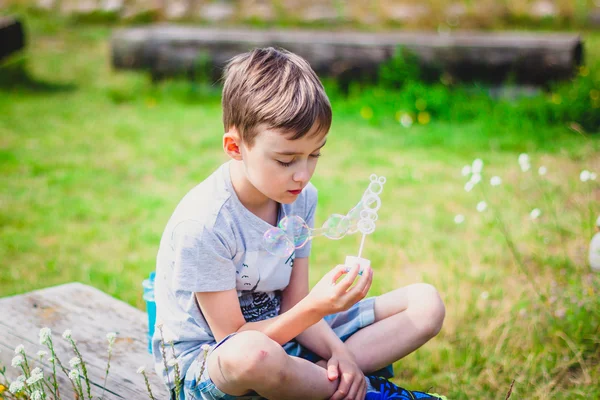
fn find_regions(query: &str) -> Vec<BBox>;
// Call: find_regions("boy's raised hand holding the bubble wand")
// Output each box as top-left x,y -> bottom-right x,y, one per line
306,264 -> 373,316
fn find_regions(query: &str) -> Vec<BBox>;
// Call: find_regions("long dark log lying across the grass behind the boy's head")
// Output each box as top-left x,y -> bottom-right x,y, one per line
111,25 -> 583,85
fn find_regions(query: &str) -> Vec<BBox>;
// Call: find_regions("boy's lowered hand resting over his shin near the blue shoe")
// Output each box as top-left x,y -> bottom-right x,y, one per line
327,354 -> 367,400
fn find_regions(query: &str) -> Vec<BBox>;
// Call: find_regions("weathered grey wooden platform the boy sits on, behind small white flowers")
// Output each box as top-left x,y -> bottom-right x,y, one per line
0,283 -> 168,399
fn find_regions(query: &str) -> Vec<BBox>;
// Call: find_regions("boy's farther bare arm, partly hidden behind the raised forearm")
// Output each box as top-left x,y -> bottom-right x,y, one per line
281,257 -> 349,360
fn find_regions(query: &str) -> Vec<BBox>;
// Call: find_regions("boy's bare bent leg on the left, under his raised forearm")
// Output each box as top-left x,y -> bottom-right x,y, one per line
207,331 -> 338,400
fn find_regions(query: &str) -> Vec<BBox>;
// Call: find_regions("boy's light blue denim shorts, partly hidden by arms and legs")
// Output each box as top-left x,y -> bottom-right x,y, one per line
183,297 -> 394,400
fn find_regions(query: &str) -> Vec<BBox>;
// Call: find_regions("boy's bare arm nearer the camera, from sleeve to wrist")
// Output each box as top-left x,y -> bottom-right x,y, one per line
195,289 -> 323,345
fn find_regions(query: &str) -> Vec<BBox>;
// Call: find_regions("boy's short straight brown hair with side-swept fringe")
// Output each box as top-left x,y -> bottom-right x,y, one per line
221,47 -> 332,146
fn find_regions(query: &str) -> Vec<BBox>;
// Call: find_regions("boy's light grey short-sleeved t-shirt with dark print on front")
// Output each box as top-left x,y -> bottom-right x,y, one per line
152,162 -> 317,388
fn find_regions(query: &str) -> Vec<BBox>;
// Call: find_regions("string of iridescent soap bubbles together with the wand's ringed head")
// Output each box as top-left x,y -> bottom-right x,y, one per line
263,174 -> 386,257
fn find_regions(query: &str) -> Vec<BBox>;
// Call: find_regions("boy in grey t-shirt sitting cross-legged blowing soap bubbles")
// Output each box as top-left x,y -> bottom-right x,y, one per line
153,48 -> 445,400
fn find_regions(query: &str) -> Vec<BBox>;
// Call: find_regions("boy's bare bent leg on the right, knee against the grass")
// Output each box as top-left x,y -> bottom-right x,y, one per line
346,283 -> 446,374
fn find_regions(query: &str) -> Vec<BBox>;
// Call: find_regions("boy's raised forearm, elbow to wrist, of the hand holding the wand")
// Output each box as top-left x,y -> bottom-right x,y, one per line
238,298 -> 324,345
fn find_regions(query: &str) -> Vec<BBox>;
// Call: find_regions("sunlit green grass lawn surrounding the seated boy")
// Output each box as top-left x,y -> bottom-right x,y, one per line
0,9 -> 600,399
